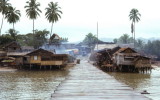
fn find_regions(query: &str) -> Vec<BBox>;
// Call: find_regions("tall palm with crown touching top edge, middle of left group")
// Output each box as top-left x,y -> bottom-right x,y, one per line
24,0 -> 42,34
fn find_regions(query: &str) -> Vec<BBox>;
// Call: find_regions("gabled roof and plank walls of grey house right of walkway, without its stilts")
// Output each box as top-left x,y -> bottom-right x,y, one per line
113,48 -> 140,66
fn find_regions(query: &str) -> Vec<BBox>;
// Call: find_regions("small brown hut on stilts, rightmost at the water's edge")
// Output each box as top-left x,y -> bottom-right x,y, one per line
134,56 -> 152,73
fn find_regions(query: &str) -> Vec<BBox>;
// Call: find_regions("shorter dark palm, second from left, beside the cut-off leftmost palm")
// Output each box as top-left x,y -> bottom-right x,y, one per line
5,7 -> 21,30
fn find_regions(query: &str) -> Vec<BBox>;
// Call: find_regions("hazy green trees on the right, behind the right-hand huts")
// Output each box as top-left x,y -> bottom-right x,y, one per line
113,34 -> 160,60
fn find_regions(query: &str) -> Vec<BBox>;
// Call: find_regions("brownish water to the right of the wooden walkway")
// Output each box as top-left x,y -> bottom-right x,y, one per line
108,68 -> 160,100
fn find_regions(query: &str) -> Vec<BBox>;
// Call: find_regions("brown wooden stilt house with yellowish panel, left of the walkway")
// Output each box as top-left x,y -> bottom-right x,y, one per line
24,49 -> 68,69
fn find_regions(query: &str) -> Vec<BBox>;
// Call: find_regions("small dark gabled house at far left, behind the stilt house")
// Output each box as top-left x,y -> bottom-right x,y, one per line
3,41 -> 21,52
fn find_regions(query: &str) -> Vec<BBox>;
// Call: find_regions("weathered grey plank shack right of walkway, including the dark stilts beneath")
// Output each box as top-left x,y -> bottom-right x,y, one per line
113,48 -> 140,72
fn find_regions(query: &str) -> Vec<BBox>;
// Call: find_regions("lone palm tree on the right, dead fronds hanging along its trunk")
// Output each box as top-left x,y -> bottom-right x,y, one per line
129,8 -> 141,46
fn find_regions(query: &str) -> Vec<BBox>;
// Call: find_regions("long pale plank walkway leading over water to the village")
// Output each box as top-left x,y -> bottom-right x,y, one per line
51,60 -> 150,100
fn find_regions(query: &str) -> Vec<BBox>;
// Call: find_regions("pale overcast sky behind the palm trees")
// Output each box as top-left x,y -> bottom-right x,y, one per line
0,0 -> 160,42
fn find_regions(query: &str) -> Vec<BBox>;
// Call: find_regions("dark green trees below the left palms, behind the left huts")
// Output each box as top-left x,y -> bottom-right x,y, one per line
0,29 -> 68,48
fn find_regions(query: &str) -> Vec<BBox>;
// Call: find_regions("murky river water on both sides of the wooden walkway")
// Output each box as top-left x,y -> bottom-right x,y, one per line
0,68 -> 160,100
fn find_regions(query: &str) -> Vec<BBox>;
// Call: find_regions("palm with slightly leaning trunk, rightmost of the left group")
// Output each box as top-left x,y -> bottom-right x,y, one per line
45,2 -> 62,37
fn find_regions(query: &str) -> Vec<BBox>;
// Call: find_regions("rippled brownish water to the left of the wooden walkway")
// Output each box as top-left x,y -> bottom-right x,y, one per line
0,70 -> 68,100
